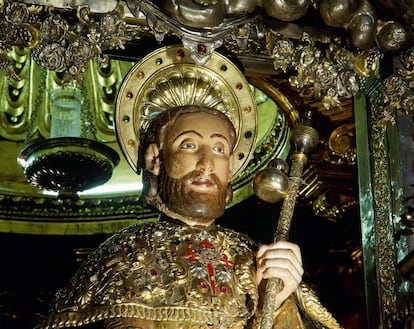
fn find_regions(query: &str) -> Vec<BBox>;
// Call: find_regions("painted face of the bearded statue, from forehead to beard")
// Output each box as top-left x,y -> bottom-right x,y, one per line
161,112 -> 233,224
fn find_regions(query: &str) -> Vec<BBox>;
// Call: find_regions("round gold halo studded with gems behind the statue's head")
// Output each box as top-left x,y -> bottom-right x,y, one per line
114,46 -> 257,179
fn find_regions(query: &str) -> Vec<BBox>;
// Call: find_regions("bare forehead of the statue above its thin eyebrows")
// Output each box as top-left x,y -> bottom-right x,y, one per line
167,112 -> 231,143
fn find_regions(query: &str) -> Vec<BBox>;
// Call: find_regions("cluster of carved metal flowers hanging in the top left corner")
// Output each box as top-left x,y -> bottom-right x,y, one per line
0,1 -> 125,82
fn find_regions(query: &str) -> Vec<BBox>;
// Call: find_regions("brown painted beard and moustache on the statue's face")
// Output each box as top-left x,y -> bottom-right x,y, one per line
158,168 -> 231,224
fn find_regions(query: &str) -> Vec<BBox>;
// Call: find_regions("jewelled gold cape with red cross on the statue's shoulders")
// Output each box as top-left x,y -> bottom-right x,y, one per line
42,220 -> 339,329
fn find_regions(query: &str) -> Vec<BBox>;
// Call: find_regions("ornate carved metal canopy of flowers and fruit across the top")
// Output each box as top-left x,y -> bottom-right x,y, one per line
0,0 -> 409,108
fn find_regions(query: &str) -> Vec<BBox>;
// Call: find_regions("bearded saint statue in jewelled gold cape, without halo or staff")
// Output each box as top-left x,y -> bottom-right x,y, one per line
41,106 -> 340,329
